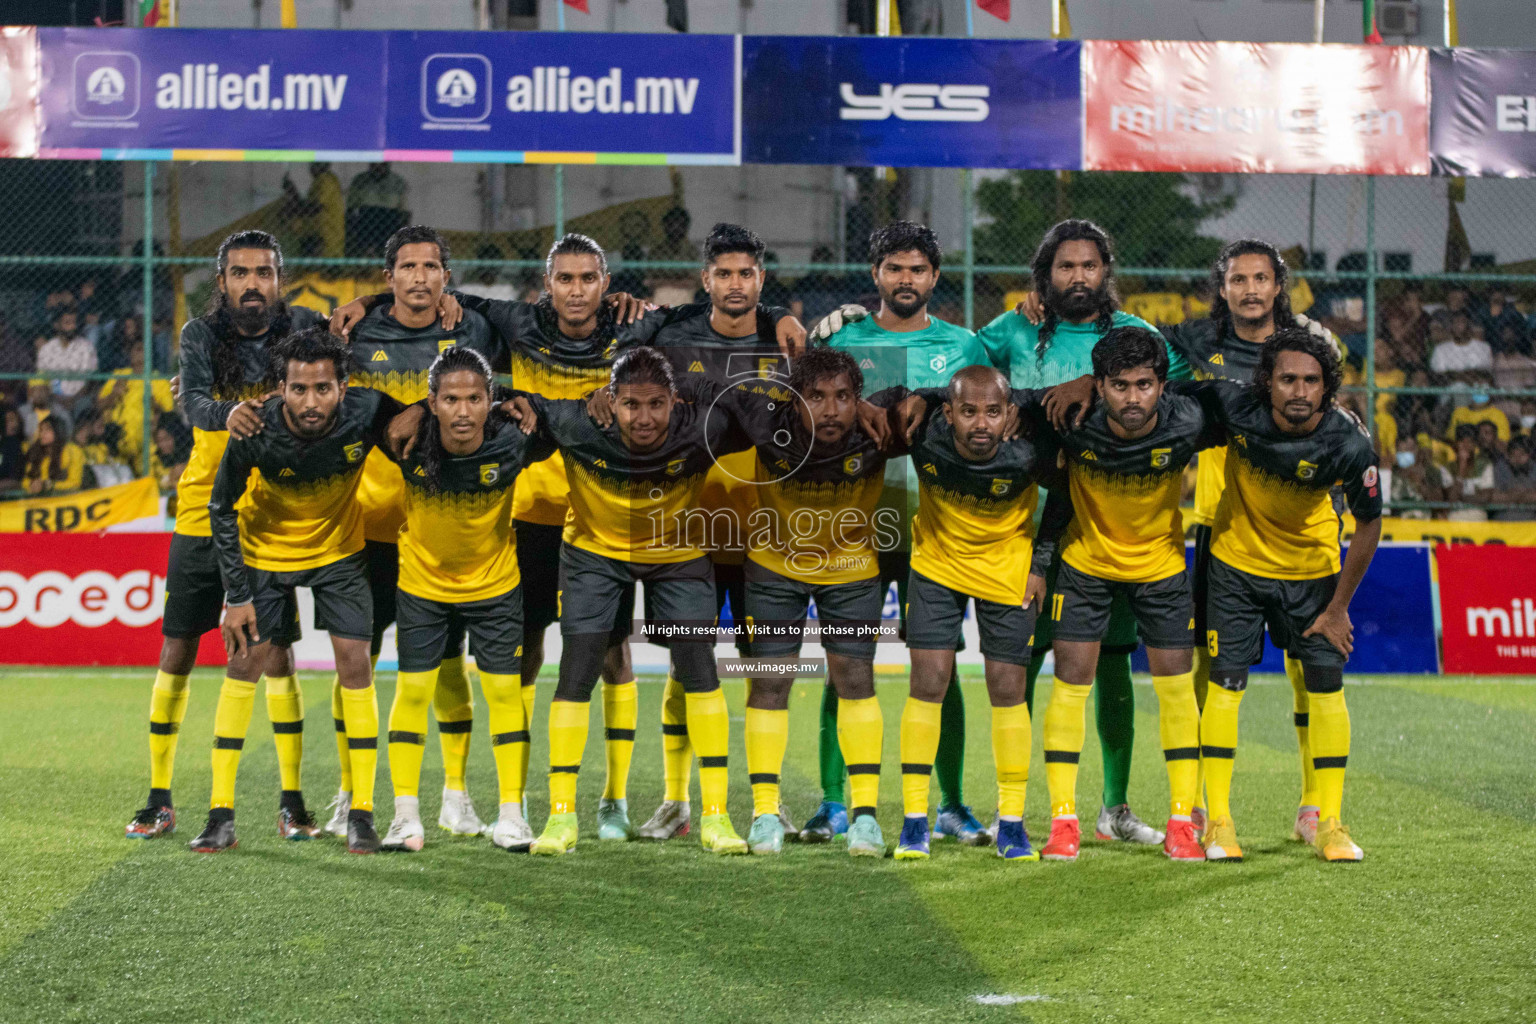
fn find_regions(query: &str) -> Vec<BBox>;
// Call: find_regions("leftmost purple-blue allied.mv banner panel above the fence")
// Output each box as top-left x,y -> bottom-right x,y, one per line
37,28 -> 387,155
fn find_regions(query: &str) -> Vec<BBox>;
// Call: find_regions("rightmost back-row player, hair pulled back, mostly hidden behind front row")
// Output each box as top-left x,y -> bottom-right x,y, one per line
1163,238 -> 1342,843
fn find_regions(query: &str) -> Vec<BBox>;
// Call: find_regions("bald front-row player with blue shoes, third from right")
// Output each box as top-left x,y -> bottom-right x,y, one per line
895,367 -> 1064,860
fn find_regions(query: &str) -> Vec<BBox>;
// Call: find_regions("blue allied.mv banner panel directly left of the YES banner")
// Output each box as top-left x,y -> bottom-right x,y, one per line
386,32 -> 740,164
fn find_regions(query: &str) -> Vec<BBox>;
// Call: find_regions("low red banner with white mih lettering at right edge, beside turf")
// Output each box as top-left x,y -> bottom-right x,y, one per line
1435,543 -> 1536,674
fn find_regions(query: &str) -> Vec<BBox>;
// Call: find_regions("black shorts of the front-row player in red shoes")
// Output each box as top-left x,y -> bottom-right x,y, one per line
1046,562 -> 1195,649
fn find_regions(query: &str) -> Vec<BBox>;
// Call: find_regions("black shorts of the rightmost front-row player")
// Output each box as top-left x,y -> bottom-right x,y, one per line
1206,559 -> 1347,672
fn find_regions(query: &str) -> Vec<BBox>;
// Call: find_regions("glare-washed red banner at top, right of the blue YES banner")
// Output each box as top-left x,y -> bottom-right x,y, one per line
1083,40 -> 1430,173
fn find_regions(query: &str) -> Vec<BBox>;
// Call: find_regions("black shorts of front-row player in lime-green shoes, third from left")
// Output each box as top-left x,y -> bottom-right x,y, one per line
561,543 -> 714,643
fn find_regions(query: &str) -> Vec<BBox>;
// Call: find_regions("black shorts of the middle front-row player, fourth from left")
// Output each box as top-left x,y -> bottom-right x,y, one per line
746,559 -> 885,662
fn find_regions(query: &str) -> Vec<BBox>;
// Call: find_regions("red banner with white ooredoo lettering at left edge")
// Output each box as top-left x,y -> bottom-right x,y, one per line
0,533 -> 224,665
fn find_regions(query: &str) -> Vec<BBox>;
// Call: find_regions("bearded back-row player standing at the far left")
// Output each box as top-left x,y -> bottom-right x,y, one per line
127,230 -> 318,840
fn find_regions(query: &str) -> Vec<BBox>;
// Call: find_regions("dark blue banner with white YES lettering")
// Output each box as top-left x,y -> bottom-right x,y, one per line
742,35 -> 1083,169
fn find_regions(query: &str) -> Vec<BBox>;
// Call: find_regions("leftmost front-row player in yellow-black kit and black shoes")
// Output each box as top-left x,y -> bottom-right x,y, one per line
205,327 -> 401,854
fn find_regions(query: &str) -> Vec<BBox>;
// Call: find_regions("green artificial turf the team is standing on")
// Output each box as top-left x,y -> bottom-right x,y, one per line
0,669 -> 1536,1024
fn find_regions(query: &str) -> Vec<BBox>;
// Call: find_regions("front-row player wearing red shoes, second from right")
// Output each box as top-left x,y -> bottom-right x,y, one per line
1037,327 -> 1223,860
